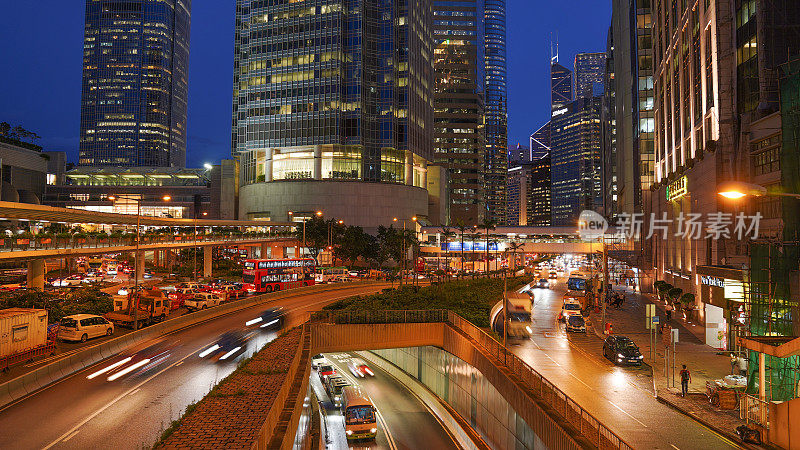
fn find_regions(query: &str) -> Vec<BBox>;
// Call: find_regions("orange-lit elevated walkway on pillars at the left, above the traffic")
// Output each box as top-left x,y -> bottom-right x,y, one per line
0,201 -> 300,289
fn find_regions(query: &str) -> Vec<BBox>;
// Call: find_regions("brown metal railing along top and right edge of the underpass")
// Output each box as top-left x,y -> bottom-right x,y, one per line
311,309 -> 633,450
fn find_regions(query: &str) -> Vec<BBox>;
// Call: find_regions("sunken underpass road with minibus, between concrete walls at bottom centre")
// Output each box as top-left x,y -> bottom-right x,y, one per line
311,353 -> 459,450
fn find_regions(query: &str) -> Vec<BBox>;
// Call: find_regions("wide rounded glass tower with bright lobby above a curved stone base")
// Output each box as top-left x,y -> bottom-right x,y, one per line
231,0 -> 434,230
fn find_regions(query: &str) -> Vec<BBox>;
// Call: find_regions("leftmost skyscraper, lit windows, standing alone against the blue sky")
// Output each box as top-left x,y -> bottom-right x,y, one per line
79,0 -> 191,167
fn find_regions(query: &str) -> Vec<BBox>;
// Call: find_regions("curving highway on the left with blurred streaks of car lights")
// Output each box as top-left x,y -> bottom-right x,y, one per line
0,285 -> 384,449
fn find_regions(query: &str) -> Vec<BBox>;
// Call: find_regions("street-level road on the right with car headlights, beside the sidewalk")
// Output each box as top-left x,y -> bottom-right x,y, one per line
510,279 -> 739,450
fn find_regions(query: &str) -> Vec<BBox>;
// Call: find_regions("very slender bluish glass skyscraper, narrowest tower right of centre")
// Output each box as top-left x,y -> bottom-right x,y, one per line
484,0 -> 508,223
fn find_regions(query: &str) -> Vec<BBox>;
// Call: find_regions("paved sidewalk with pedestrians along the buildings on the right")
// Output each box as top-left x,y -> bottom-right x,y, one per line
590,286 -> 758,448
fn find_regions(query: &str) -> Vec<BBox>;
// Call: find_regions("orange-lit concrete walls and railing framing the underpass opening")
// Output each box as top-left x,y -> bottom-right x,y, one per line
260,310 -> 631,450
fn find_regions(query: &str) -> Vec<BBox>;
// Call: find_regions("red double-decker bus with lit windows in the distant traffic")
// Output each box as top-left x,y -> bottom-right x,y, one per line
242,258 -> 317,292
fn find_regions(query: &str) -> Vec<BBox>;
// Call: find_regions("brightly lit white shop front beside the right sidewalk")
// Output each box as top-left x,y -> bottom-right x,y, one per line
696,266 -> 746,350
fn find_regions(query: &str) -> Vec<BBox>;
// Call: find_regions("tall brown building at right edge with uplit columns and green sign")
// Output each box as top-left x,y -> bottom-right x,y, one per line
647,0 -> 800,352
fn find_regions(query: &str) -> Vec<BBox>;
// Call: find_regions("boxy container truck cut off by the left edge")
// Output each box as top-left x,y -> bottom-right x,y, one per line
0,308 -> 55,371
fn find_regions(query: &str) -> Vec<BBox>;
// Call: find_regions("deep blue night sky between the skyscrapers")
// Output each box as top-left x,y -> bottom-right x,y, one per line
0,0 -> 611,167
